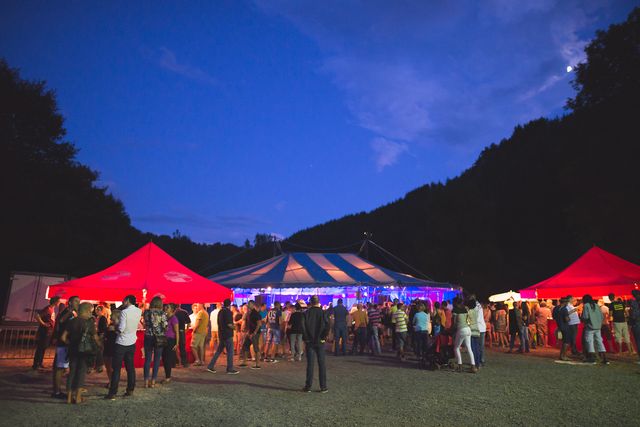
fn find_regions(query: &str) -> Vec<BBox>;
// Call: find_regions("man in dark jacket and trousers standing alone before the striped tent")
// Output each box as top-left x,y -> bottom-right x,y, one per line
302,295 -> 329,393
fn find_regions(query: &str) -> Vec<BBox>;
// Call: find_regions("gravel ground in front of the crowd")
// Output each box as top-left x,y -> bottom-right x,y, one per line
0,350 -> 640,427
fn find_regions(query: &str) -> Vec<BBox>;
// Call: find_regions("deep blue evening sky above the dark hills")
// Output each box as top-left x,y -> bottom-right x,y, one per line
0,0 -> 638,243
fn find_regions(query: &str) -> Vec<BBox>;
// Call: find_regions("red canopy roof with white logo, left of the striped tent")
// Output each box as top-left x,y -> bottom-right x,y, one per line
49,243 -> 233,304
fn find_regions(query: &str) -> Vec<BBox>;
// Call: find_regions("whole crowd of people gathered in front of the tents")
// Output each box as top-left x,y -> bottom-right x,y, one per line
33,290 -> 640,403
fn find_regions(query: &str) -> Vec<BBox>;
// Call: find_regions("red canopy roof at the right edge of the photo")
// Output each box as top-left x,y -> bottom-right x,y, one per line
520,246 -> 640,298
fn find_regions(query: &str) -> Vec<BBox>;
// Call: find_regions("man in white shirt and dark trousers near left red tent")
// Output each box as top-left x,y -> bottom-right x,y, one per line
106,295 -> 142,400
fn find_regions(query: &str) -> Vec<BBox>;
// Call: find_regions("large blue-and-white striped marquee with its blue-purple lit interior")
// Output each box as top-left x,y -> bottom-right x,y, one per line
209,252 -> 460,305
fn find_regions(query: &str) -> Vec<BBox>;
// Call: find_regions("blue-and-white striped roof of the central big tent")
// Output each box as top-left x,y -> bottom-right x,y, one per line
209,252 -> 451,289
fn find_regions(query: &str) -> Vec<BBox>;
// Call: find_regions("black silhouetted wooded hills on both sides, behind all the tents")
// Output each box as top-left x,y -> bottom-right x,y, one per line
0,9 -> 640,298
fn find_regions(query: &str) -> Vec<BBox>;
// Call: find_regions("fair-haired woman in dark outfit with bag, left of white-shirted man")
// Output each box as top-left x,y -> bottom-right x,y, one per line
61,302 -> 99,403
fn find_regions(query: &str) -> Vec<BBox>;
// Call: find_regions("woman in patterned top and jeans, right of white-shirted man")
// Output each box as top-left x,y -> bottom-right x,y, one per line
143,296 -> 167,388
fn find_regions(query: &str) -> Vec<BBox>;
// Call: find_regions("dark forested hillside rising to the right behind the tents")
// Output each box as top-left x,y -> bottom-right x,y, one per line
290,9 -> 640,295
